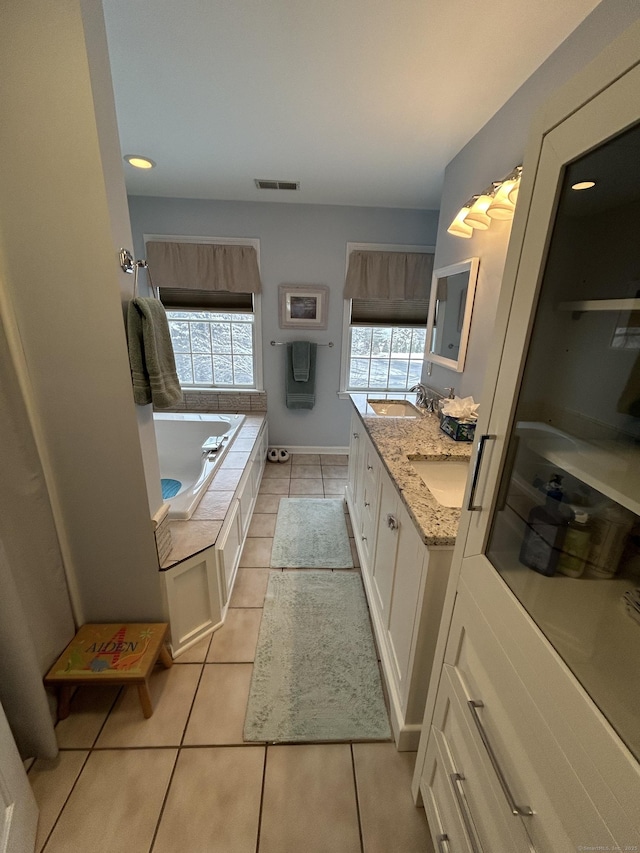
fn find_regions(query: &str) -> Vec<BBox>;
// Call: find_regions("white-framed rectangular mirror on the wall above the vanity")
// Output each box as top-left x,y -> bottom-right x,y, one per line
426,258 -> 479,373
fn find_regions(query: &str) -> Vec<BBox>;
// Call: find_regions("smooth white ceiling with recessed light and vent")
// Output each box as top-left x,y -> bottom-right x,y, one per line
103,0 -> 599,209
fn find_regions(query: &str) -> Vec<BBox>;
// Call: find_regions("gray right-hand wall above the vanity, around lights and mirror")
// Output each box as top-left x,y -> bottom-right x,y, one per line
423,0 -> 640,410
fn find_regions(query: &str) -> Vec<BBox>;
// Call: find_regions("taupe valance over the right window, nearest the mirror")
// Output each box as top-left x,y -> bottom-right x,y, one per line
344,250 -> 433,300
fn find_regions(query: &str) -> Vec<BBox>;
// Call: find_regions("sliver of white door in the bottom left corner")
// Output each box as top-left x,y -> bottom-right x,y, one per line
0,705 -> 38,853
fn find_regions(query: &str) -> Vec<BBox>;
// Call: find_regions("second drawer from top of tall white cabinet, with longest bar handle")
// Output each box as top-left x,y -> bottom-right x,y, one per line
433,666 -> 531,853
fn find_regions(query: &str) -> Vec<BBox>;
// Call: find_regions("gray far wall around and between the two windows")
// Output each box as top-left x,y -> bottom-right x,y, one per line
129,196 -> 438,448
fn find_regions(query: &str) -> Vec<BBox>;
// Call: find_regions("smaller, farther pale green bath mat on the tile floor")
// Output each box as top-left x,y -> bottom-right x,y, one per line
271,498 -> 353,569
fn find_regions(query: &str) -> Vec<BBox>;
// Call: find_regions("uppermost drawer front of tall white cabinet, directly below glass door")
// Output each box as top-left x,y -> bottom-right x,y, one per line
445,584 -> 615,853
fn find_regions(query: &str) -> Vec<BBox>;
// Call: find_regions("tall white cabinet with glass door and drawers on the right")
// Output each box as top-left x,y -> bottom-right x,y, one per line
413,24 -> 640,853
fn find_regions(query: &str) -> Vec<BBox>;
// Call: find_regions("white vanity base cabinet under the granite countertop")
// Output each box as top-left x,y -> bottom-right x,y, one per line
347,414 -> 452,750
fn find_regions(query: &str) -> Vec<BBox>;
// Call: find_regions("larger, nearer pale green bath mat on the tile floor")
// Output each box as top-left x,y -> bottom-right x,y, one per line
244,571 -> 391,743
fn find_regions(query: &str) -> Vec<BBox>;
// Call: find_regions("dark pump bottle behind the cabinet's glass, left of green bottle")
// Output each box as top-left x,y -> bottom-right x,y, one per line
520,474 -> 566,577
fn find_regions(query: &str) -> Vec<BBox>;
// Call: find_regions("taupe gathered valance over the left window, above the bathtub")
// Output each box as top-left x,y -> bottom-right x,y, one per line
146,240 -> 262,293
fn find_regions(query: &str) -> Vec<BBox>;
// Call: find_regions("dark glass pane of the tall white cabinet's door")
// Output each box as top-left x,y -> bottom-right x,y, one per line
484,118 -> 640,760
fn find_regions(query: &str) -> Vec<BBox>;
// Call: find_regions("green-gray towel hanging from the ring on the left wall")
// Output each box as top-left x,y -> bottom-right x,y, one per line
127,296 -> 182,409
